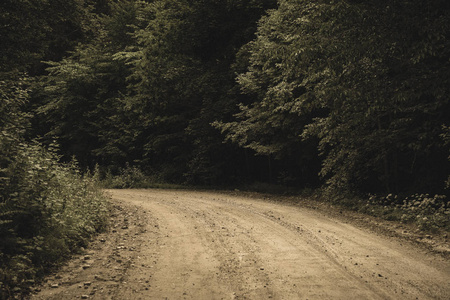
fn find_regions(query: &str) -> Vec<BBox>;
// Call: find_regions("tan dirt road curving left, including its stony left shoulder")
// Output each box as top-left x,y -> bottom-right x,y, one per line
33,190 -> 450,299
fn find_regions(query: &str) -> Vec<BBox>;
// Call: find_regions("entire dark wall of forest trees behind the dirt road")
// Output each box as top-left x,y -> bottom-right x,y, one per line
0,0 -> 450,193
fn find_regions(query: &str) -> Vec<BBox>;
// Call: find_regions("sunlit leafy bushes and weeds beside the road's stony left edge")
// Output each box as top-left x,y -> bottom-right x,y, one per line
0,142 -> 108,299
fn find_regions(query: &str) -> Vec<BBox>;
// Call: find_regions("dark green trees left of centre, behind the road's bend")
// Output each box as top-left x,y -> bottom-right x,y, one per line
34,0 -> 275,184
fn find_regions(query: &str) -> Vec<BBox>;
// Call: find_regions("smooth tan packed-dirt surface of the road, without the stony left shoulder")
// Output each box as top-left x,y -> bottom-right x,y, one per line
110,190 -> 450,299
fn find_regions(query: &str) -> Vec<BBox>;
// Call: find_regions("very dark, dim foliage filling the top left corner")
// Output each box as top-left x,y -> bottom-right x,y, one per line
0,0 -> 92,74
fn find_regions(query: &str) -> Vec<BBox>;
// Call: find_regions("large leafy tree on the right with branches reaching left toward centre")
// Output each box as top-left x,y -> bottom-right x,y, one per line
222,0 -> 450,195
